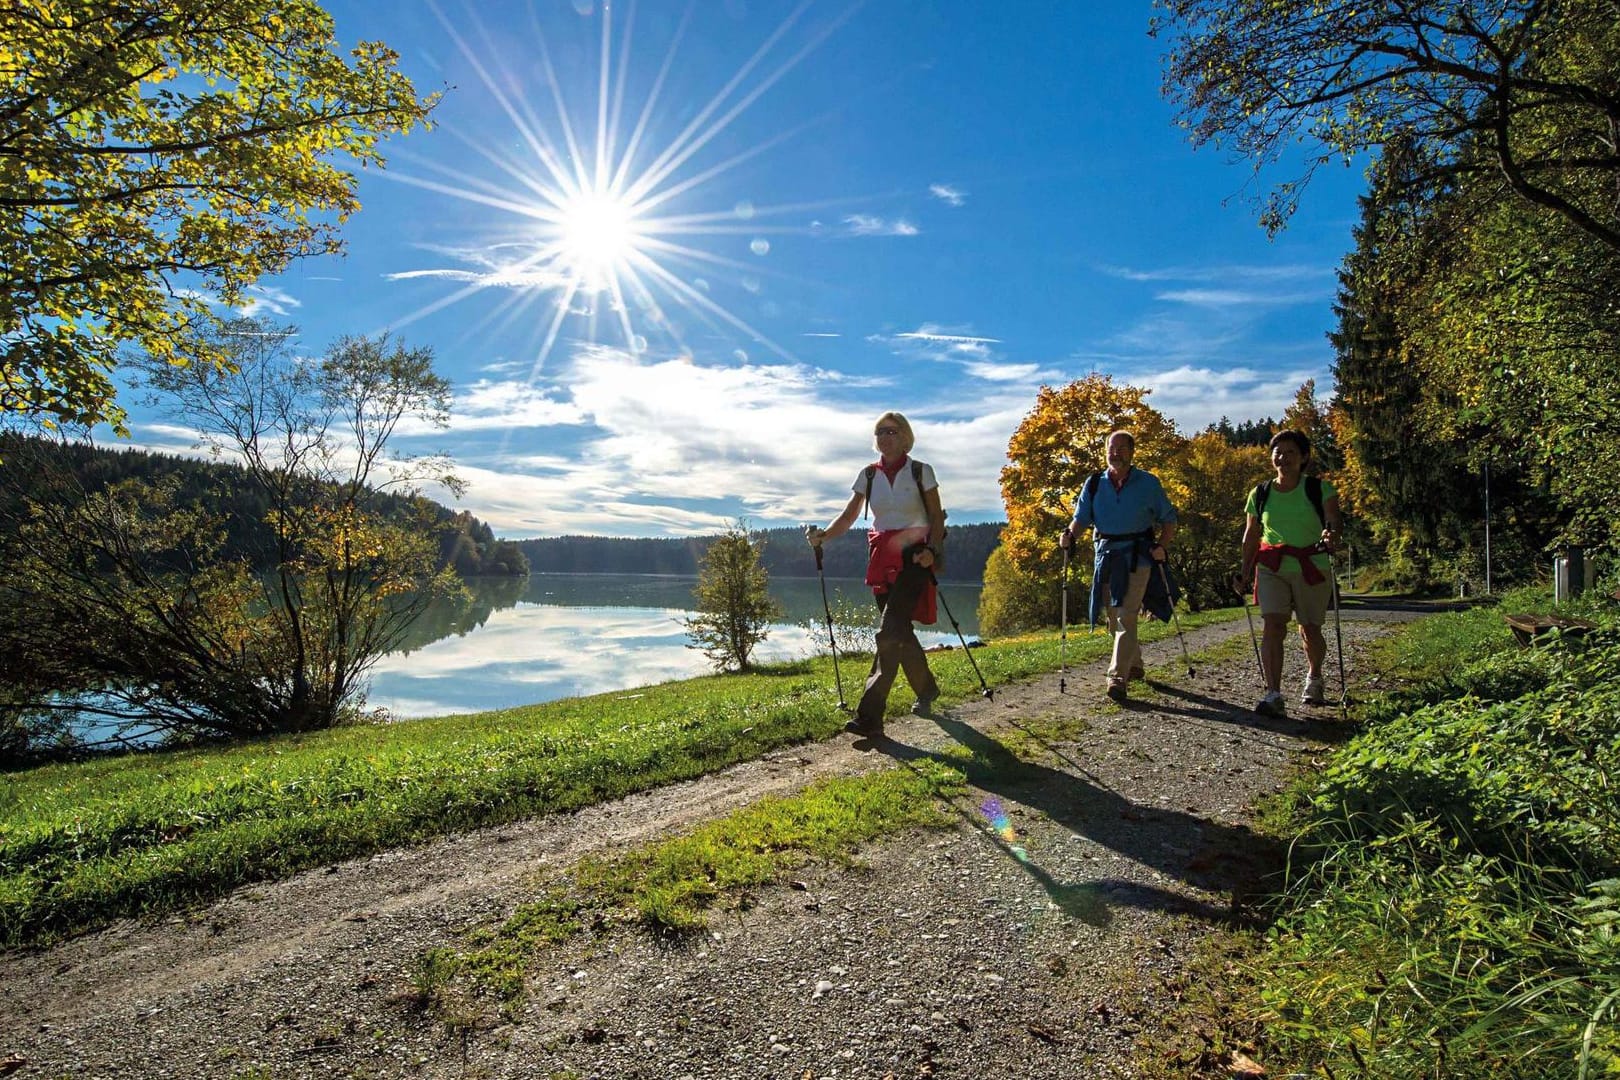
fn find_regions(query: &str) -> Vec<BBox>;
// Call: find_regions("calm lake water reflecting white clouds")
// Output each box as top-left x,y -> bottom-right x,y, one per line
368,573 -> 980,717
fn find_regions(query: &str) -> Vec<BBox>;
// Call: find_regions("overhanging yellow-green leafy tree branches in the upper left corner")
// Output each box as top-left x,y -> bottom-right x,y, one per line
0,0 -> 437,431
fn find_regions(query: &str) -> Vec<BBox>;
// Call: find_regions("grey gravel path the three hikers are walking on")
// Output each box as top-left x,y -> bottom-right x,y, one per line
0,615 -> 1398,1080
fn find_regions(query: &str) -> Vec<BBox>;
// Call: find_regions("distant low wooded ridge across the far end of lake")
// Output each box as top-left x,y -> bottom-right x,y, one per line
514,521 -> 1001,581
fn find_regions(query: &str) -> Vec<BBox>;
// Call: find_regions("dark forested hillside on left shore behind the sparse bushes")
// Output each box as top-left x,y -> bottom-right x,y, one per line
0,436 -> 528,576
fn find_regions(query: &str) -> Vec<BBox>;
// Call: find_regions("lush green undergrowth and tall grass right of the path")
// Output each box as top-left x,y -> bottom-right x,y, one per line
1146,596 -> 1620,1080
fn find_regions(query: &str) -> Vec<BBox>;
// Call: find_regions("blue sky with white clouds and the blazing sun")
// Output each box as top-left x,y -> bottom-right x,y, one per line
134,0 -> 1361,538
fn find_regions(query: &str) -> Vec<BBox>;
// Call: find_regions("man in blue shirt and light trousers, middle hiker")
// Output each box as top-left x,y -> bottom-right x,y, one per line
1058,431 -> 1176,701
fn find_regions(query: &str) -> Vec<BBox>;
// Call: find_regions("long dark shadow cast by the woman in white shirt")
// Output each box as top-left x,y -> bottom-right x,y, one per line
873,714 -> 1286,926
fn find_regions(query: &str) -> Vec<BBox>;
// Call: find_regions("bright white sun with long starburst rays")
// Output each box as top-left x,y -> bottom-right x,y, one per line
389,0 -> 859,381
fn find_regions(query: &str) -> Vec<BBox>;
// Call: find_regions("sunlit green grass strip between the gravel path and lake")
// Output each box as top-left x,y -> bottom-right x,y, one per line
0,610 -> 1234,947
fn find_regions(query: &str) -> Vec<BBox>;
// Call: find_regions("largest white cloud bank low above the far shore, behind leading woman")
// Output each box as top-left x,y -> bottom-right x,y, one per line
403,335 -> 1038,536
